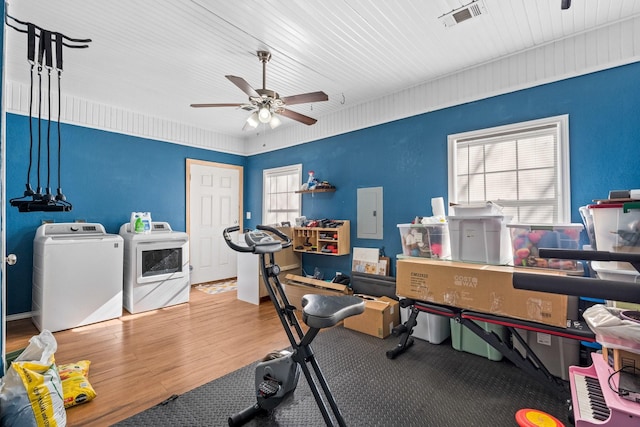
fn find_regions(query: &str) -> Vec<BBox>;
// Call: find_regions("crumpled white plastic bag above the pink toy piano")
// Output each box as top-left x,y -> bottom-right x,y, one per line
582,304 -> 640,353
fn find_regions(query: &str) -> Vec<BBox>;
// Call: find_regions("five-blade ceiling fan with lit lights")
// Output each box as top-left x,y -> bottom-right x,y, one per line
191,50 -> 329,130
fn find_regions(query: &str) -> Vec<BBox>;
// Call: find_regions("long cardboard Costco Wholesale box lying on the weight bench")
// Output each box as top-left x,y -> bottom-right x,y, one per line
396,258 -> 568,328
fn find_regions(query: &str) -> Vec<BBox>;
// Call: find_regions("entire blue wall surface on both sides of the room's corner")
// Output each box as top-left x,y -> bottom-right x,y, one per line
7,63 -> 640,314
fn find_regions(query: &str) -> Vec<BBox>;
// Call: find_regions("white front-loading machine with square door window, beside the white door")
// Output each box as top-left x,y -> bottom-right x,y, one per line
120,221 -> 191,313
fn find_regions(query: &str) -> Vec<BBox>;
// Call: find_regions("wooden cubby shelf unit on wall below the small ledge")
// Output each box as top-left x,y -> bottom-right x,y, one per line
293,220 -> 351,256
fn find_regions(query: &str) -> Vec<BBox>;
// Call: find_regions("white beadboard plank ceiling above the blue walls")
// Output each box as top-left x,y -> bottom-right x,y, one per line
5,0 -> 640,149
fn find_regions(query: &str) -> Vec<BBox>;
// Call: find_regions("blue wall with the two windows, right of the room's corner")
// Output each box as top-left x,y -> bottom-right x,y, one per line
245,63 -> 640,278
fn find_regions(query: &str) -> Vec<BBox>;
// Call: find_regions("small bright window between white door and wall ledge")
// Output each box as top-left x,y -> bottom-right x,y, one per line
262,164 -> 302,225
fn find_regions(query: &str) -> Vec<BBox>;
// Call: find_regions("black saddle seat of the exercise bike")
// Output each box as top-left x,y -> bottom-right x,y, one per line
302,294 -> 364,329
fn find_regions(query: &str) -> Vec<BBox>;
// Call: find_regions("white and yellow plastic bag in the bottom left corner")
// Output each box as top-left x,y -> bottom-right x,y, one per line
0,330 -> 67,427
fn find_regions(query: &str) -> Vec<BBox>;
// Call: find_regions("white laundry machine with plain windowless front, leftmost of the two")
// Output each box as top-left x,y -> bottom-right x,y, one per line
31,223 -> 124,332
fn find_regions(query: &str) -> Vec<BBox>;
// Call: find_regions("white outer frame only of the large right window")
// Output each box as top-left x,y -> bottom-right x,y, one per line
447,114 -> 571,224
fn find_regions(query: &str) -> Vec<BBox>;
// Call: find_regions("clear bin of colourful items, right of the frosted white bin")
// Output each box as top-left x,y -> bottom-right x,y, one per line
507,224 -> 584,273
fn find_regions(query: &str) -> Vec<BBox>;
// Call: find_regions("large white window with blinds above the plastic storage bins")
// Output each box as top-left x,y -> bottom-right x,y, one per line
448,115 -> 571,224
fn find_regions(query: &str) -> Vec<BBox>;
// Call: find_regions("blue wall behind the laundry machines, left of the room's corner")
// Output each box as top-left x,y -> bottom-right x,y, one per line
6,114 -> 246,314
